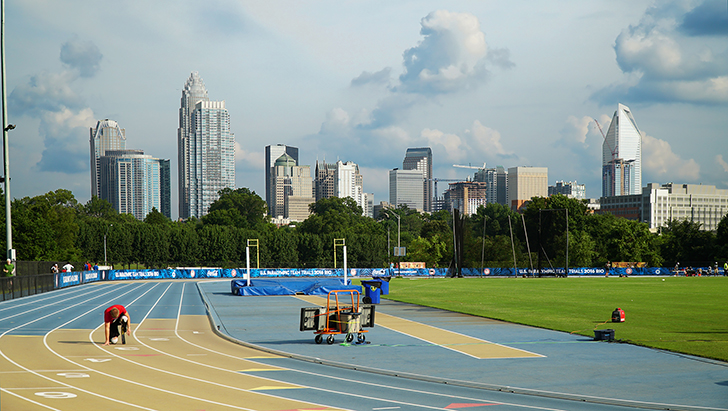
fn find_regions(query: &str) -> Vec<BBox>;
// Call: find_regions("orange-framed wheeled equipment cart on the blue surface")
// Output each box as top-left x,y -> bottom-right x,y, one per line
300,290 -> 374,344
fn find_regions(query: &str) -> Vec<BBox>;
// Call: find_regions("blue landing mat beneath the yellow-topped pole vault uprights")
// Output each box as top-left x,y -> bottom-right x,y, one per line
230,278 -> 361,296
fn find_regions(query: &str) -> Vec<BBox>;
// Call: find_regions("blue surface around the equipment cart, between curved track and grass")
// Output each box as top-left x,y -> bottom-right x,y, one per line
199,281 -> 728,409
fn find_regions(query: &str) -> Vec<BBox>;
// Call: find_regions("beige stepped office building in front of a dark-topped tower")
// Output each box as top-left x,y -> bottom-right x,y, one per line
269,153 -> 314,222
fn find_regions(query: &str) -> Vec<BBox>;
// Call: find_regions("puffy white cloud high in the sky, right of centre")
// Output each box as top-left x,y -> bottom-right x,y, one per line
395,10 -> 512,94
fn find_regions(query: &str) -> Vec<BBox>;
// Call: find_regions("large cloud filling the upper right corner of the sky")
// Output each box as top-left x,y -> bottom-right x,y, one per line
592,2 -> 728,104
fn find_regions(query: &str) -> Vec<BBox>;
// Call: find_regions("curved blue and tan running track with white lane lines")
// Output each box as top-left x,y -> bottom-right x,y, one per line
0,281 -> 728,411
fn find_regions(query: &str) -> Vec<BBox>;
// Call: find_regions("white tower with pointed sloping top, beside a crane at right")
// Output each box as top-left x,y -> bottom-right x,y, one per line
602,104 -> 642,197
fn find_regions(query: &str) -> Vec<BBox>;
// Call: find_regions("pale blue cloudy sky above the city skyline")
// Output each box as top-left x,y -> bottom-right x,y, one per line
5,0 -> 728,217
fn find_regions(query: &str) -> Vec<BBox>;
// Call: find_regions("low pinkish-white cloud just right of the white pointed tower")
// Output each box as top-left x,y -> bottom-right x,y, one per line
642,134 -> 700,181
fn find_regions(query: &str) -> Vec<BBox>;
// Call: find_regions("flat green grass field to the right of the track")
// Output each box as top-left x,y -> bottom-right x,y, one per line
384,277 -> 728,361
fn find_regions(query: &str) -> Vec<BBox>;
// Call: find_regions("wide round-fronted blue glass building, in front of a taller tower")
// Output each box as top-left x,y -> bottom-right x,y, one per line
99,150 -> 171,220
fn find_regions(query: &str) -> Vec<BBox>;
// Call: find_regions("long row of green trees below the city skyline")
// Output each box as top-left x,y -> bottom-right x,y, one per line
0,188 -> 728,274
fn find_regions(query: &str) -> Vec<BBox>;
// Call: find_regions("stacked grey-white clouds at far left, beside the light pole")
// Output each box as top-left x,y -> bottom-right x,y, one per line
8,40 -> 101,174
